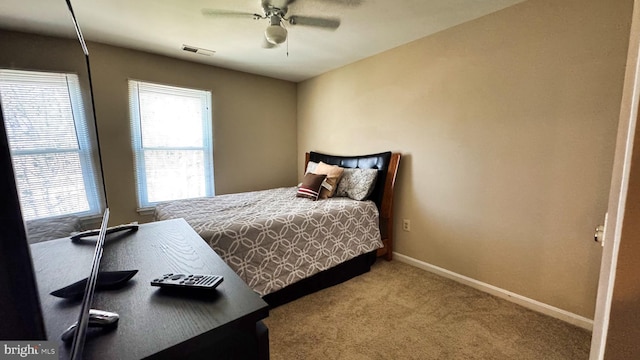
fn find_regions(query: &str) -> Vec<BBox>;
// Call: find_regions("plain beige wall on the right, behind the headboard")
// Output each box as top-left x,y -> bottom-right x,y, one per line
298,0 -> 632,318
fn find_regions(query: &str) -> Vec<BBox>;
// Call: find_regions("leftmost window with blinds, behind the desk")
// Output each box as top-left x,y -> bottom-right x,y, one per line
0,70 -> 102,220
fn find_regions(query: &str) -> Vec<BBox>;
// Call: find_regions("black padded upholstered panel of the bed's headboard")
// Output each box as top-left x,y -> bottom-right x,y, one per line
309,151 -> 391,209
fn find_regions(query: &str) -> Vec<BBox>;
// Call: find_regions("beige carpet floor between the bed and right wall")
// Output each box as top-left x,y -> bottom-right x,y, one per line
265,260 -> 591,360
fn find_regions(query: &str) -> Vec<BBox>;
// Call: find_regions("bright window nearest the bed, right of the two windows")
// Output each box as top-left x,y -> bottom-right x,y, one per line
129,81 -> 214,208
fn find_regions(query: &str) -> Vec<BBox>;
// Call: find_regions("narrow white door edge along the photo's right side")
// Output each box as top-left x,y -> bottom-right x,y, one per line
589,0 -> 640,360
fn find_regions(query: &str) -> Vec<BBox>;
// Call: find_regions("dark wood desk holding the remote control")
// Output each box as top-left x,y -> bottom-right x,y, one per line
31,219 -> 269,359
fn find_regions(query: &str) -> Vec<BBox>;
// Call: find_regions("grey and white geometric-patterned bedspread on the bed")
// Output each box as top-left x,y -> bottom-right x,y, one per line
155,187 -> 382,296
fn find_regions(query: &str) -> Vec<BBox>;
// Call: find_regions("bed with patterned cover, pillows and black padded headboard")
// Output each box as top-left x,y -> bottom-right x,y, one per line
155,152 -> 400,307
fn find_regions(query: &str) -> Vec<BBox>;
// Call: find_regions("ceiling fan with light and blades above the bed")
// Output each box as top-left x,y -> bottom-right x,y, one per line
202,0 -> 348,49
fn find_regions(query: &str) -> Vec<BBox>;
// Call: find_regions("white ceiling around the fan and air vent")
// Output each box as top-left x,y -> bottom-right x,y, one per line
0,0 -> 524,82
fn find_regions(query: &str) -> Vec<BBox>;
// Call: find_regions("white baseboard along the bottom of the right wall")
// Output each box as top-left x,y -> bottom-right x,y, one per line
393,252 -> 593,331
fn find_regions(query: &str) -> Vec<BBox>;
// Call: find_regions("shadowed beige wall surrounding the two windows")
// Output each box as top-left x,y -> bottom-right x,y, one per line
0,31 -> 298,224
